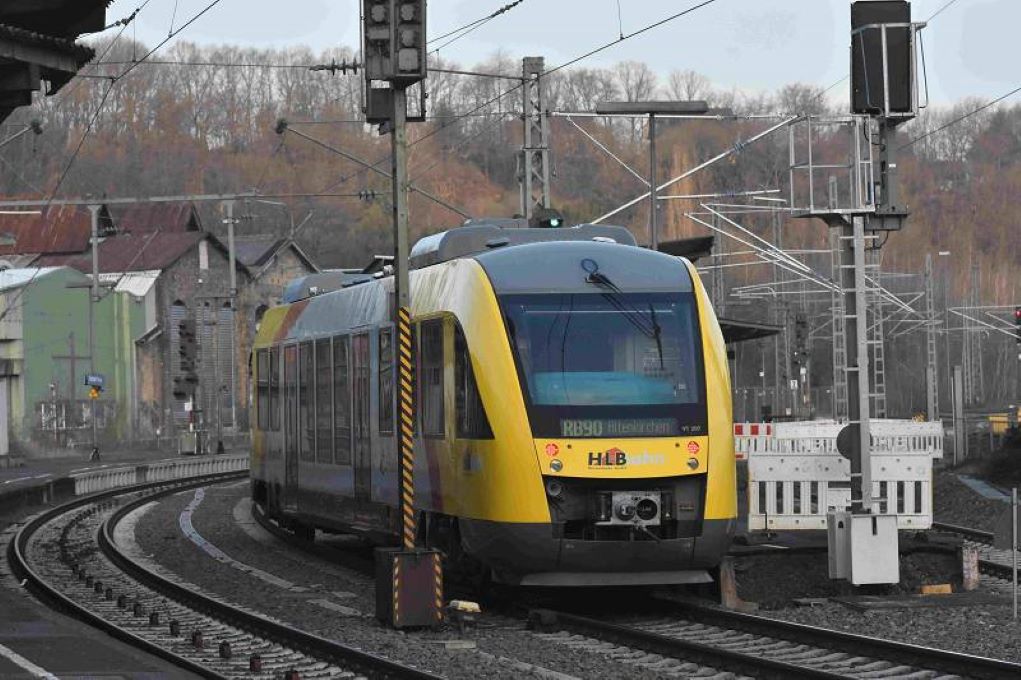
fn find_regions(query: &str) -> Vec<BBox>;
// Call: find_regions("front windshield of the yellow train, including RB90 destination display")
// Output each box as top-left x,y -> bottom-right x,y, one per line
502,291 -> 706,437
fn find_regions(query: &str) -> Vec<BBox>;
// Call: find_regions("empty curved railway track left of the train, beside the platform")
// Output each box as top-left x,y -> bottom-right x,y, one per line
7,472 -> 439,680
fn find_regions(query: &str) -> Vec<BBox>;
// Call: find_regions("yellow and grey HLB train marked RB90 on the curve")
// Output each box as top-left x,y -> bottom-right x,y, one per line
252,221 -> 737,586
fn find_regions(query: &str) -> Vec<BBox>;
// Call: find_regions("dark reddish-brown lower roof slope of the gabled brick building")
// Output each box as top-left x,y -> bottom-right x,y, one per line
38,232 -> 207,274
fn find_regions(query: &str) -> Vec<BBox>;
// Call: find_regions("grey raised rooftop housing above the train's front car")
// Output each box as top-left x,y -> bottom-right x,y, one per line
410,218 -> 637,270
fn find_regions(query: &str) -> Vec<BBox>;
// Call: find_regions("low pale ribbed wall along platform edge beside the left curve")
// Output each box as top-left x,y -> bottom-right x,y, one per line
70,453 -> 248,496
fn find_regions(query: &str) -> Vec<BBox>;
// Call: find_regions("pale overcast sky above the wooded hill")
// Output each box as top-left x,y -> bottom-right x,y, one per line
107,0 -> 1021,103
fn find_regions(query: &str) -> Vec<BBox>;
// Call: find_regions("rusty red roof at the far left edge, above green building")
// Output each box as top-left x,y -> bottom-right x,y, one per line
0,205 -> 103,256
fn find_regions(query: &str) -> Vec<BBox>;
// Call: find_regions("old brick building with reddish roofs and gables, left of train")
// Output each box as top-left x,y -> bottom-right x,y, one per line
0,204 -> 317,443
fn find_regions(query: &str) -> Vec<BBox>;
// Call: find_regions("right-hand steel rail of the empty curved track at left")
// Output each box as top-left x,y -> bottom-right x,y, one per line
98,479 -> 440,680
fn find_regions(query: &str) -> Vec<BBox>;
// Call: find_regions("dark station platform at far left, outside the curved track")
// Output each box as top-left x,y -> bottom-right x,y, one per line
0,450 -> 227,680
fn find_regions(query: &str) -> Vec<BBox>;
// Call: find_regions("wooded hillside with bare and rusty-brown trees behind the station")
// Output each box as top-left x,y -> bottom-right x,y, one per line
0,41 -> 1021,411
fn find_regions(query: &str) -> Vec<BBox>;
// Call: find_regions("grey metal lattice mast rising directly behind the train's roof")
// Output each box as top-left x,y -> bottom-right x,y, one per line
518,57 -> 550,218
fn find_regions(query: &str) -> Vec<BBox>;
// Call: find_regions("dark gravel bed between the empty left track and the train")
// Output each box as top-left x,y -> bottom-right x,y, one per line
136,485 -> 659,680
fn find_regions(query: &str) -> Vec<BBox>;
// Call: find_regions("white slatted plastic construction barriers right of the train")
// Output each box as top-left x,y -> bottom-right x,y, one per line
734,420 -> 943,531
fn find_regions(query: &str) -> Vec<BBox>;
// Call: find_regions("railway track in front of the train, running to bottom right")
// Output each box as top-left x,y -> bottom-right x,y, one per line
530,600 -> 1021,680
